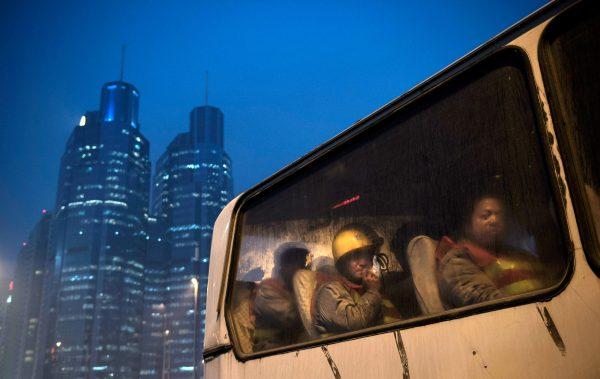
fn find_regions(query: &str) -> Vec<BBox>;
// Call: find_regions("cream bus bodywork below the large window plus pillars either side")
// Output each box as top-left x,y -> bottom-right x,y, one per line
205,2 -> 600,378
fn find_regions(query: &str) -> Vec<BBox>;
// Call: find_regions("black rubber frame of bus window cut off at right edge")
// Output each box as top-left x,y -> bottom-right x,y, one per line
538,1 -> 600,277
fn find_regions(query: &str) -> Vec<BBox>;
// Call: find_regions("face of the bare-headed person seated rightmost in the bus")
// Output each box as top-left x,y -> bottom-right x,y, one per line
468,198 -> 505,248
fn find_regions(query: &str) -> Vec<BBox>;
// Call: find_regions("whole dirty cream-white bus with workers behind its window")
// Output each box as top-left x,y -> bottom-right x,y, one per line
204,1 -> 600,378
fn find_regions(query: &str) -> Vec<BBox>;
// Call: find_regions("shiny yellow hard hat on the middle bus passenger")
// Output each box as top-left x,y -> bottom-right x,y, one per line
332,224 -> 383,261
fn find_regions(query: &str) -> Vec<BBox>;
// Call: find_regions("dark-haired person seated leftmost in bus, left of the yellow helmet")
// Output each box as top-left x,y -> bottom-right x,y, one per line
253,243 -> 309,351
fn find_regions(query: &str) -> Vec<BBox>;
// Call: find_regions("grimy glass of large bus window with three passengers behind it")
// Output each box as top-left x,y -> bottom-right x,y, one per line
228,49 -> 567,354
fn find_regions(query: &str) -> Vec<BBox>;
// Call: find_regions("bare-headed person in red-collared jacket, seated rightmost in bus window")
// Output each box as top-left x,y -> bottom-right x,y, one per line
436,194 -> 544,307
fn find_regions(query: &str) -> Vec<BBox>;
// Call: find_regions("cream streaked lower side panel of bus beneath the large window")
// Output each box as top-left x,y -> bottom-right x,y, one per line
206,249 -> 600,378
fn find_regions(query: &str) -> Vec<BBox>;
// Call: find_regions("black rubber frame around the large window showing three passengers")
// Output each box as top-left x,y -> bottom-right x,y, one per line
223,44 -> 574,362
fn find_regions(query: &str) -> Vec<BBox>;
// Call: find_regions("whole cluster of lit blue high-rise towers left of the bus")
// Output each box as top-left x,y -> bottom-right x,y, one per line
0,76 -> 233,378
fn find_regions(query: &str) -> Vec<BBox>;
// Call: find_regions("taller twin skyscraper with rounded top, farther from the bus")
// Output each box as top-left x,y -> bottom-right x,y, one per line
36,81 -> 150,378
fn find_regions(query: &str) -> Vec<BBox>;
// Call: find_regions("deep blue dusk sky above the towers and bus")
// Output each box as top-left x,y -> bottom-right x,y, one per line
0,0 -> 545,278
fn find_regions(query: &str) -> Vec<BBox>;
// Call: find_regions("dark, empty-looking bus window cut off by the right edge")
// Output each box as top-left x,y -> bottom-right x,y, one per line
540,1 -> 600,274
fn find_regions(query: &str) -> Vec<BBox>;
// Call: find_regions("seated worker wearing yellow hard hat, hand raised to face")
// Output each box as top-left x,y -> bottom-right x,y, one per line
314,224 -> 399,336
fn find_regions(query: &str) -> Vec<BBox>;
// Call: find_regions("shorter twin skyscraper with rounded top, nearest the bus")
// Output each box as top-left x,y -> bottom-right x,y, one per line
152,105 -> 233,378
